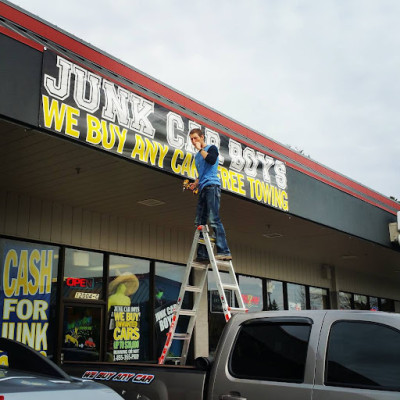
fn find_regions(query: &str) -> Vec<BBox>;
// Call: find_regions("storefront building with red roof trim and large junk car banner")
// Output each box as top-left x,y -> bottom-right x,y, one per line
0,1 -> 400,363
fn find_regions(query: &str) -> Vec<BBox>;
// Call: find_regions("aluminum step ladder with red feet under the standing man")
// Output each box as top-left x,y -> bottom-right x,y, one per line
158,225 -> 248,365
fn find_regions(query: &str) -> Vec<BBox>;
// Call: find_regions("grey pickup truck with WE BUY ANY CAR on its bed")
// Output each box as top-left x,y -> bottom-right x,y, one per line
63,310 -> 400,400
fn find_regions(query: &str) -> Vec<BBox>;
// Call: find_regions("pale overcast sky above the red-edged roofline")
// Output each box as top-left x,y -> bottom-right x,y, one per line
9,0 -> 400,199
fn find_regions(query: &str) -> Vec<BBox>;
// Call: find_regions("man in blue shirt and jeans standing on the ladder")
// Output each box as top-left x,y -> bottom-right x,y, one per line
189,128 -> 232,263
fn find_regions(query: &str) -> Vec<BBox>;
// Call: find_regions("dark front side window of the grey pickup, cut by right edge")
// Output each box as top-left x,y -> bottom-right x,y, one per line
325,321 -> 400,391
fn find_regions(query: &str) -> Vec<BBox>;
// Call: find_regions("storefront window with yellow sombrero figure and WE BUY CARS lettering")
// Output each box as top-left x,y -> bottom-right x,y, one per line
107,256 -> 151,362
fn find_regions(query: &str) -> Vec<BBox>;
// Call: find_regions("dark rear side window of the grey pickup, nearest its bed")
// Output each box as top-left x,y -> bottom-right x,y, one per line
229,321 -> 311,383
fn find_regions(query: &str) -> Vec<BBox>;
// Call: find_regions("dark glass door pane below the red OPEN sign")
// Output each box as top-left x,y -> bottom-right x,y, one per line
62,305 -> 101,361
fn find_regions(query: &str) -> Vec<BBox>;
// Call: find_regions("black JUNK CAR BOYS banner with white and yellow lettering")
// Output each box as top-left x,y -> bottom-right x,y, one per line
40,50 -> 289,211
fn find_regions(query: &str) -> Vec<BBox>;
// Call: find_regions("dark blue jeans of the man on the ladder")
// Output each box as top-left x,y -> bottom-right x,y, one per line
195,185 -> 231,259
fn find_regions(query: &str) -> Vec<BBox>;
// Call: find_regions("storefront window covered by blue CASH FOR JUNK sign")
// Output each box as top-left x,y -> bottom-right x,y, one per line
0,239 -> 59,357
